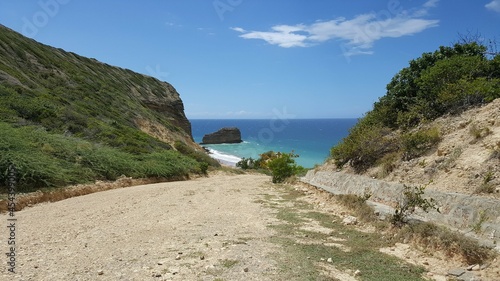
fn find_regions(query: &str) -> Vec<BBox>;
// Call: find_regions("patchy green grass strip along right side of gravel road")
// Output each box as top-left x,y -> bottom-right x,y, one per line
262,185 -> 424,281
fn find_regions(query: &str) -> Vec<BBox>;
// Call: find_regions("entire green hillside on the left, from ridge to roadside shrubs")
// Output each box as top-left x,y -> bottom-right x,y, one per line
0,25 -> 219,190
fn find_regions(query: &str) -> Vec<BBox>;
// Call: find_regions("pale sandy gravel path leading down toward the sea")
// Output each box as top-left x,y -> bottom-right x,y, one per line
0,175 -> 279,281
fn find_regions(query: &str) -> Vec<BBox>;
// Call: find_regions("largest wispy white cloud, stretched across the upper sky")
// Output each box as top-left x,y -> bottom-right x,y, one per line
231,0 -> 440,56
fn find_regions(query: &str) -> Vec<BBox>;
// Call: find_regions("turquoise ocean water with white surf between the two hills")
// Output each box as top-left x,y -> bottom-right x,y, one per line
190,119 -> 357,168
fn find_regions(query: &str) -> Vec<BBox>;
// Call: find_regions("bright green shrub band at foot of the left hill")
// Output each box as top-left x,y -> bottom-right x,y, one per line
0,122 -> 203,191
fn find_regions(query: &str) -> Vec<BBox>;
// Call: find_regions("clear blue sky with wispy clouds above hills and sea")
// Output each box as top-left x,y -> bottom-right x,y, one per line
0,0 -> 500,119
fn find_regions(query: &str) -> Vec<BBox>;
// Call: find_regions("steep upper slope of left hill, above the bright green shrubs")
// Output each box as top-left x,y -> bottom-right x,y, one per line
0,25 -> 198,150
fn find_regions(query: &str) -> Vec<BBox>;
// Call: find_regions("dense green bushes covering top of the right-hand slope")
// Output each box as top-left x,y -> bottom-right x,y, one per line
331,41 -> 500,173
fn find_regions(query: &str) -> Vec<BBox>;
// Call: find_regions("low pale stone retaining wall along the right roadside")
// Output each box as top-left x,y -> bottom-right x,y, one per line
301,170 -> 500,249
